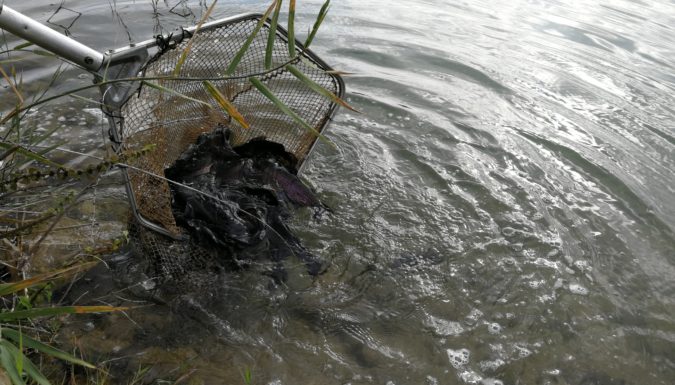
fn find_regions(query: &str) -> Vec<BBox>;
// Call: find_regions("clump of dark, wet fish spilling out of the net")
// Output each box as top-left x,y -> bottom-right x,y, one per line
165,130 -> 327,281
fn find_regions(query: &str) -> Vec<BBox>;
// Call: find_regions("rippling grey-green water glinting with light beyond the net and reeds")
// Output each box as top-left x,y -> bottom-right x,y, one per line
1,0 -> 675,385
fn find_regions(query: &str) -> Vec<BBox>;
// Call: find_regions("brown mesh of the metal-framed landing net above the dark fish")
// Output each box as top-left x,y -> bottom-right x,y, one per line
120,17 -> 342,238
